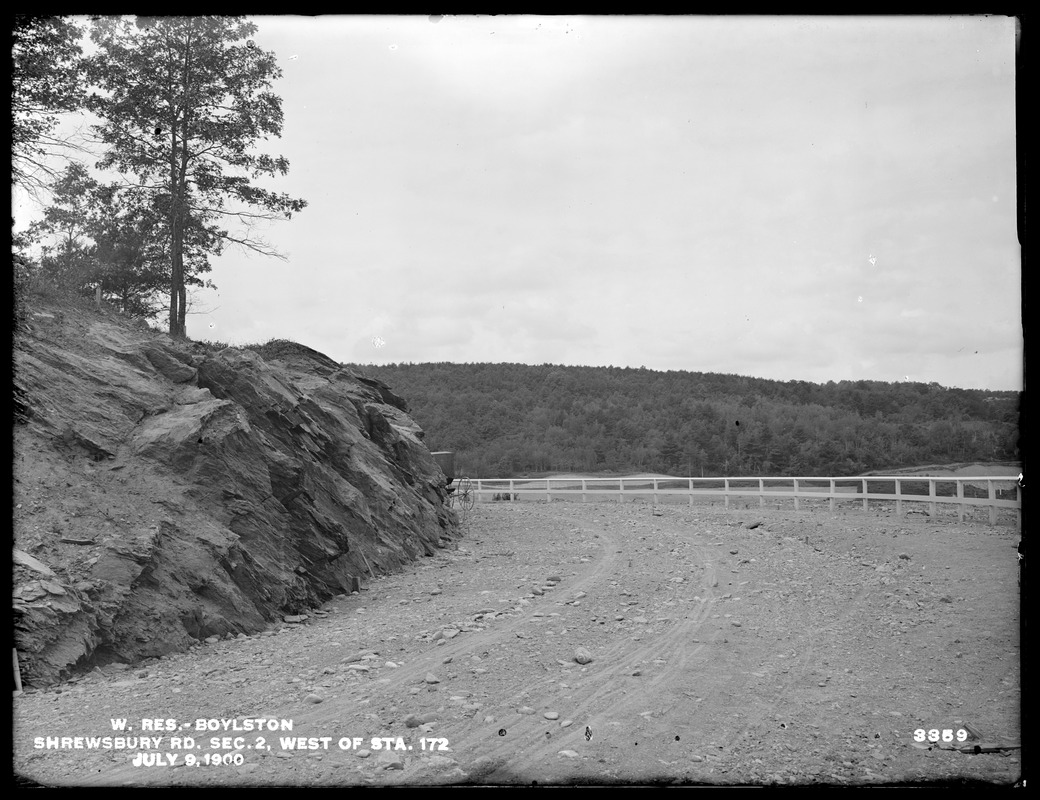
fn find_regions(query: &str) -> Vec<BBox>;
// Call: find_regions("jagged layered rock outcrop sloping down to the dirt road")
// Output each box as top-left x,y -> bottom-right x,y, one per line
14,295 -> 458,685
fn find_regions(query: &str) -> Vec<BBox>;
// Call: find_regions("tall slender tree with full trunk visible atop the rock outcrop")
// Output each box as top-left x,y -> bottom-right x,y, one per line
86,17 -> 307,337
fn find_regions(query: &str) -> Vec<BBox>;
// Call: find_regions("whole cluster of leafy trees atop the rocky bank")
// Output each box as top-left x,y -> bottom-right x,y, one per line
11,16 -> 307,337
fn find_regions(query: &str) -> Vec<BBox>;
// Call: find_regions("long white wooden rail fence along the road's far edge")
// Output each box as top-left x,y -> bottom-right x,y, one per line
471,475 -> 1022,524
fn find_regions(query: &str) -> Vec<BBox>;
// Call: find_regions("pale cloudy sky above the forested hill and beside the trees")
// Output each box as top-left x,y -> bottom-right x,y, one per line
14,16 -> 1023,390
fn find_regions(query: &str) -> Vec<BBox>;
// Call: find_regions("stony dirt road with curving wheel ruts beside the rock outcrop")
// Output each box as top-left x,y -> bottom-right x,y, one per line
15,502 -> 1022,786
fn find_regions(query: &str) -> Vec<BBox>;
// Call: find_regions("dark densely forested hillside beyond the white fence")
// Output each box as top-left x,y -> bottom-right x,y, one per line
352,363 -> 1019,478
